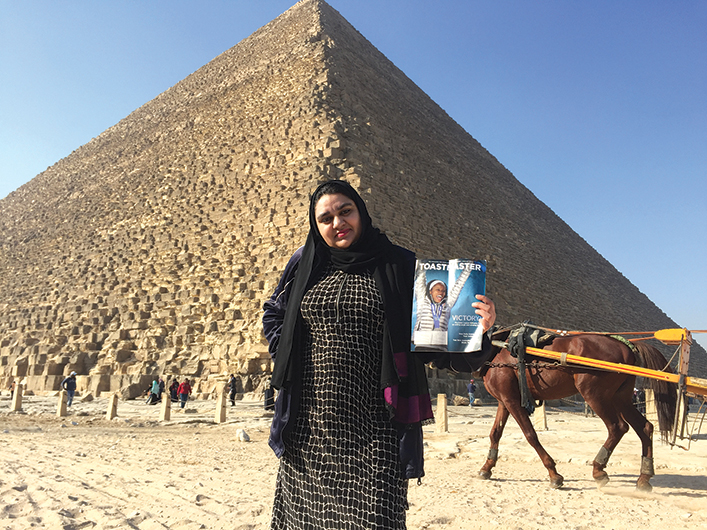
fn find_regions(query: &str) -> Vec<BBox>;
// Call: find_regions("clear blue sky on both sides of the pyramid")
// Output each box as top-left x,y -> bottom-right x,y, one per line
0,0 -> 707,345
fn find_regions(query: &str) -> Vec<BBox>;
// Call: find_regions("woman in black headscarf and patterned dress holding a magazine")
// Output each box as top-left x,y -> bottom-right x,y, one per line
263,181 -> 495,530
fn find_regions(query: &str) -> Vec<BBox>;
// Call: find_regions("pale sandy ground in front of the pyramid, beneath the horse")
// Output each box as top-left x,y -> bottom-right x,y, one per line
0,392 -> 707,530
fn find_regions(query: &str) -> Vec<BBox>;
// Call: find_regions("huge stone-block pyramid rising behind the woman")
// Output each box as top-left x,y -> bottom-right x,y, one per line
0,0 -> 704,397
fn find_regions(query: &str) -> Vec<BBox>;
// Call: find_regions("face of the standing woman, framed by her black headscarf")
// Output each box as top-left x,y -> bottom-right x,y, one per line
314,193 -> 362,248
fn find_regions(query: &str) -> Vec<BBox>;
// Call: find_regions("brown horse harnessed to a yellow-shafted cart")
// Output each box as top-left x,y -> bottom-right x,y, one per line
479,332 -> 677,491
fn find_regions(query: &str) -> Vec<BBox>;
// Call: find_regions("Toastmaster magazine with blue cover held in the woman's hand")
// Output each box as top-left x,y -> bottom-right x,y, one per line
411,259 -> 486,352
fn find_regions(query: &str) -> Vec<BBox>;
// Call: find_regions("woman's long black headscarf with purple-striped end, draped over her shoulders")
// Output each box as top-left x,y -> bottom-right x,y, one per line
272,180 -> 428,422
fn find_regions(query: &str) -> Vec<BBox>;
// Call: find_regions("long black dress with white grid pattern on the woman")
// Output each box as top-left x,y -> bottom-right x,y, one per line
272,267 -> 407,530
